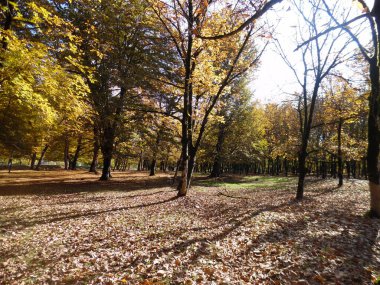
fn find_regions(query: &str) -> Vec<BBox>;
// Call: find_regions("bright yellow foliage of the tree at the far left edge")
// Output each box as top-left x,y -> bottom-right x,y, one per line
0,1 -> 87,168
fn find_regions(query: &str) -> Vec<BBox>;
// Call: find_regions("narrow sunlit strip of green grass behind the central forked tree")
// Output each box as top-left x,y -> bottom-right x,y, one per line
198,176 -> 296,190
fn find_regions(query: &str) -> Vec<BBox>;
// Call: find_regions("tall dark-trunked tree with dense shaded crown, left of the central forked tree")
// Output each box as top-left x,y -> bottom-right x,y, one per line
59,0 -> 167,180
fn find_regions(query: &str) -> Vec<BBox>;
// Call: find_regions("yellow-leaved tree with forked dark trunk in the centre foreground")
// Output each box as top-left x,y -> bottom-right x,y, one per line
150,0 -> 280,196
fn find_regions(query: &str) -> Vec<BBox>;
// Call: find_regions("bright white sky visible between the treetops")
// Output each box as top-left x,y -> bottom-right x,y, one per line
250,0 -> 373,103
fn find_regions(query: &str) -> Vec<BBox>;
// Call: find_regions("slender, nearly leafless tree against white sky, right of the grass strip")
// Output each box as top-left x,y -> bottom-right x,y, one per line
277,0 -> 350,200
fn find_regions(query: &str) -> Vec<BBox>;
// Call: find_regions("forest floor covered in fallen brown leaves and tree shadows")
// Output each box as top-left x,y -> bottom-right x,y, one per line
0,171 -> 380,285
